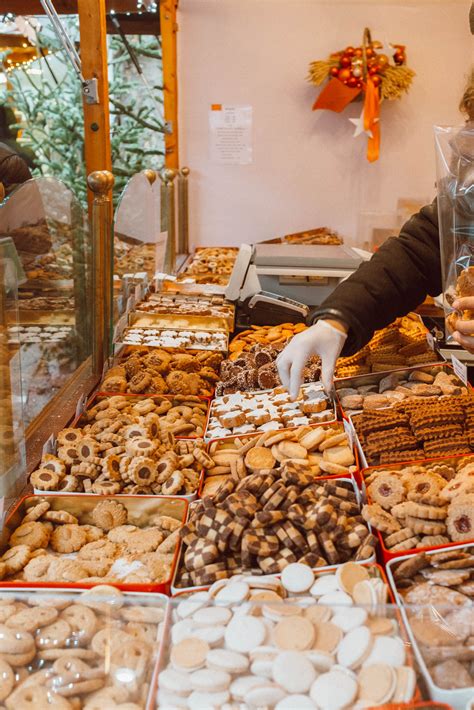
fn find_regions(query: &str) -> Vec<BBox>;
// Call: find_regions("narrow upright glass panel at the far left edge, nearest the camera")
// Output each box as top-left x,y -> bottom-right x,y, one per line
0,237 -> 25,496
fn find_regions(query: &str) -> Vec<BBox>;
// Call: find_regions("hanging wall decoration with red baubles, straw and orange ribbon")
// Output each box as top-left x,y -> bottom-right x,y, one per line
308,27 -> 415,162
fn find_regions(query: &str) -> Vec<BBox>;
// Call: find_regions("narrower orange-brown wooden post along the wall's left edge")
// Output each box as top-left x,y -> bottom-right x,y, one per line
160,0 -> 179,168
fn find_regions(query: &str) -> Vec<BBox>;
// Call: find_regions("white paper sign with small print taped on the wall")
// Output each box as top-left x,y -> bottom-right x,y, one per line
209,104 -> 252,165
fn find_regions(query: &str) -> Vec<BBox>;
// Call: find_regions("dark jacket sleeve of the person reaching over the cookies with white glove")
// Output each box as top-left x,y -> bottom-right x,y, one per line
313,200 -> 442,356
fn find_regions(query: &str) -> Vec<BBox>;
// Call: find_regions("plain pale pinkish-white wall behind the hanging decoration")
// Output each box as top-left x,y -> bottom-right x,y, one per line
178,0 -> 473,244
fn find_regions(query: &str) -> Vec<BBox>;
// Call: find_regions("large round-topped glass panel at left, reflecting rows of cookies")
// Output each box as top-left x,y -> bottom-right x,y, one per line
0,178 -> 92,424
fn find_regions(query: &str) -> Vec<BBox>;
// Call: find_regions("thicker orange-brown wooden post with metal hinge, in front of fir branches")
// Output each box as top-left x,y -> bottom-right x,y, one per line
77,0 -> 112,210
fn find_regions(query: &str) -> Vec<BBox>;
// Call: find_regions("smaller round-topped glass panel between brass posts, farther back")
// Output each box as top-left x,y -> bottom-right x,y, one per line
113,173 -> 162,323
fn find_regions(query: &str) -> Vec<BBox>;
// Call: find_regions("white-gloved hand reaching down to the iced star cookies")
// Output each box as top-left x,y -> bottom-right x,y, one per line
276,320 -> 347,400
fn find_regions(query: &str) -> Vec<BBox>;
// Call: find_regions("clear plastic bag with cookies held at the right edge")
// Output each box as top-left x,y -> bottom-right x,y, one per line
435,122 -> 474,342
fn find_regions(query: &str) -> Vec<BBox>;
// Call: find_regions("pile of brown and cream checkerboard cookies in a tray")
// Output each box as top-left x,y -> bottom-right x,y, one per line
178,461 -> 375,586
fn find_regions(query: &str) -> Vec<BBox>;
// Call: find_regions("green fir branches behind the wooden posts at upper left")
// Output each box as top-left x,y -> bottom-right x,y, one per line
0,18 -> 164,204
